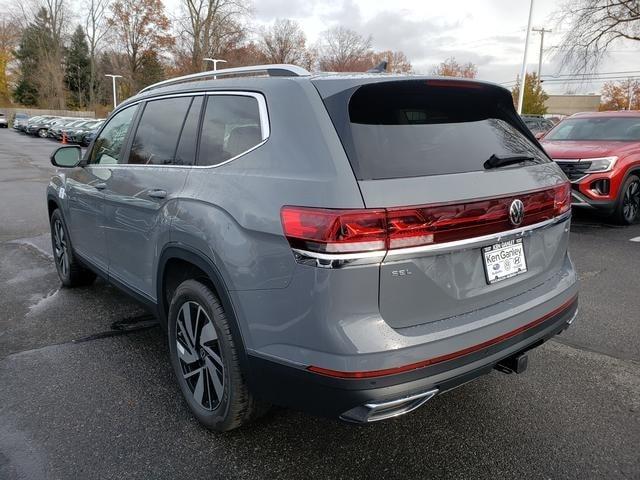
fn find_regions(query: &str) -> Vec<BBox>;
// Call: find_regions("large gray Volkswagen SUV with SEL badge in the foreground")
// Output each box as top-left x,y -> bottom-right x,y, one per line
47,65 -> 578,431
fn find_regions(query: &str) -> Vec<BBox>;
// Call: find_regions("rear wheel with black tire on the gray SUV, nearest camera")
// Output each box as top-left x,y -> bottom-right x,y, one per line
168,280 -> 269,432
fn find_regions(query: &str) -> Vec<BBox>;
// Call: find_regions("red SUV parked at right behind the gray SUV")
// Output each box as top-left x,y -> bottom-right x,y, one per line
541,111 -> 640,224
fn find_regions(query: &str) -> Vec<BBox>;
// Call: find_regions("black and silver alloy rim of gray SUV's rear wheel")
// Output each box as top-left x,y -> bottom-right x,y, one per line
176,301 -> 224,410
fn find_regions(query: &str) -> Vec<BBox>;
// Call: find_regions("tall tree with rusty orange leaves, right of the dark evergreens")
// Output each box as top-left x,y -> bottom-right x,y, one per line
108,0 -> 174,93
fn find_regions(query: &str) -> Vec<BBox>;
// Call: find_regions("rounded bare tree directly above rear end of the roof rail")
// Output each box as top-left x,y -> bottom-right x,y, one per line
260,19 -> 307,64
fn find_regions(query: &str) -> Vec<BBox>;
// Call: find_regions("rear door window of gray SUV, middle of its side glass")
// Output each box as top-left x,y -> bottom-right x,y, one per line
127,97 -> 192,165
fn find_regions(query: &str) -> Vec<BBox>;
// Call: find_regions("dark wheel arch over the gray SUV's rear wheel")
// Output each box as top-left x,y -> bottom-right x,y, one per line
156,244 -> 248,372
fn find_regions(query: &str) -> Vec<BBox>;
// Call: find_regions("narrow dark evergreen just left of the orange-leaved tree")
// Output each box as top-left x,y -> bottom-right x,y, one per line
64,25 -> 91,108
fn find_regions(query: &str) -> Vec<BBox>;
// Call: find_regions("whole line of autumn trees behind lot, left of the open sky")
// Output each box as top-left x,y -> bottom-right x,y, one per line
0,0 -> 412,109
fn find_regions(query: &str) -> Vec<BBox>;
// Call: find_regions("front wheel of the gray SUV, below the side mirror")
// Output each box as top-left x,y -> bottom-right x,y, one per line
51,209 -> 96,288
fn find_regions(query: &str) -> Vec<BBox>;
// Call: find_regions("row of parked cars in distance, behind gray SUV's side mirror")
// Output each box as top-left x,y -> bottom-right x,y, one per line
13,114 -> 104,146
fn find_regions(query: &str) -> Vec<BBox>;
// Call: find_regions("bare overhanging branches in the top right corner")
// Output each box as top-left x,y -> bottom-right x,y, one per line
556,0 -> 640,73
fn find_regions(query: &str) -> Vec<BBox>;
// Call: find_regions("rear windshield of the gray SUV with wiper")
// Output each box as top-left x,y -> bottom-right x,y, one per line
328,80 -> 549,180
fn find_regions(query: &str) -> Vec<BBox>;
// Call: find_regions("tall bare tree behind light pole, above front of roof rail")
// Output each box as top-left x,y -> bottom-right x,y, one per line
178,0 -> 250,72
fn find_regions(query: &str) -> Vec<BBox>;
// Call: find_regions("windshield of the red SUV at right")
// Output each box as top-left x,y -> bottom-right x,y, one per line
545,117 -> 640,142
